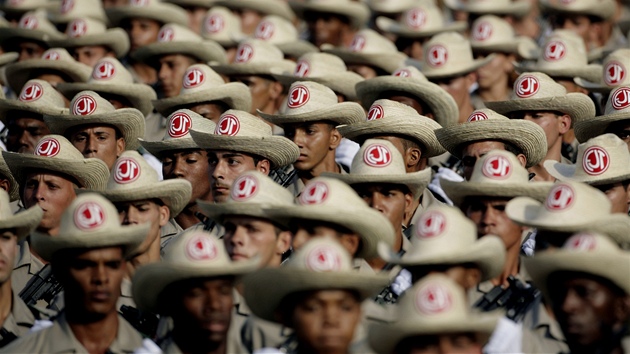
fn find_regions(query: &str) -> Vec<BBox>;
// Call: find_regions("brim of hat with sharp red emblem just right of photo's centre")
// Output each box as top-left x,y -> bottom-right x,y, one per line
321,168 -> 433,199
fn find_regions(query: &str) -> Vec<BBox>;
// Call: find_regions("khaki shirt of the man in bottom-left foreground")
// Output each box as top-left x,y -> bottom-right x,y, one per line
0,314 -> 142,353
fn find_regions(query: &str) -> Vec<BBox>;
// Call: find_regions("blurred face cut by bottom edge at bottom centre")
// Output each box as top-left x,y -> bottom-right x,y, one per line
291,290 -> 361,353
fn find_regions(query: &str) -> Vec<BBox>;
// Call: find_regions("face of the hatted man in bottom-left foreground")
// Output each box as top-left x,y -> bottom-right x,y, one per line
63,247 -> 127,316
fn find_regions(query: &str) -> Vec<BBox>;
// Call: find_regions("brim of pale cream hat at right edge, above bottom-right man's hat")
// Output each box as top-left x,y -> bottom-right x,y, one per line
506,197 -> 630,244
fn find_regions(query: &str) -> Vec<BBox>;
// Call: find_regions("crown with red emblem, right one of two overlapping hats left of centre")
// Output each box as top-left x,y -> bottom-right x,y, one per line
215,109 -> 272,137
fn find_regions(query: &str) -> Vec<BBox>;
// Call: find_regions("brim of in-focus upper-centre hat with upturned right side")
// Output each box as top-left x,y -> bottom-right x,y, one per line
256,102 -> 365,126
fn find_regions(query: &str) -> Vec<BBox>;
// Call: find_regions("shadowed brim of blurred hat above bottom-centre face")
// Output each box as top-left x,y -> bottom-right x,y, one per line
243,267 -> 389,322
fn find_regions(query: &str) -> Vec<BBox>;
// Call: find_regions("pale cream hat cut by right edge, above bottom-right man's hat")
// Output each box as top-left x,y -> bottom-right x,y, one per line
505,181 -> 630,244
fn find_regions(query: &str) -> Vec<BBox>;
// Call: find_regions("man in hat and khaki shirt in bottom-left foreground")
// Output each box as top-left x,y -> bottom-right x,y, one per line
4,193 -> 149,353
